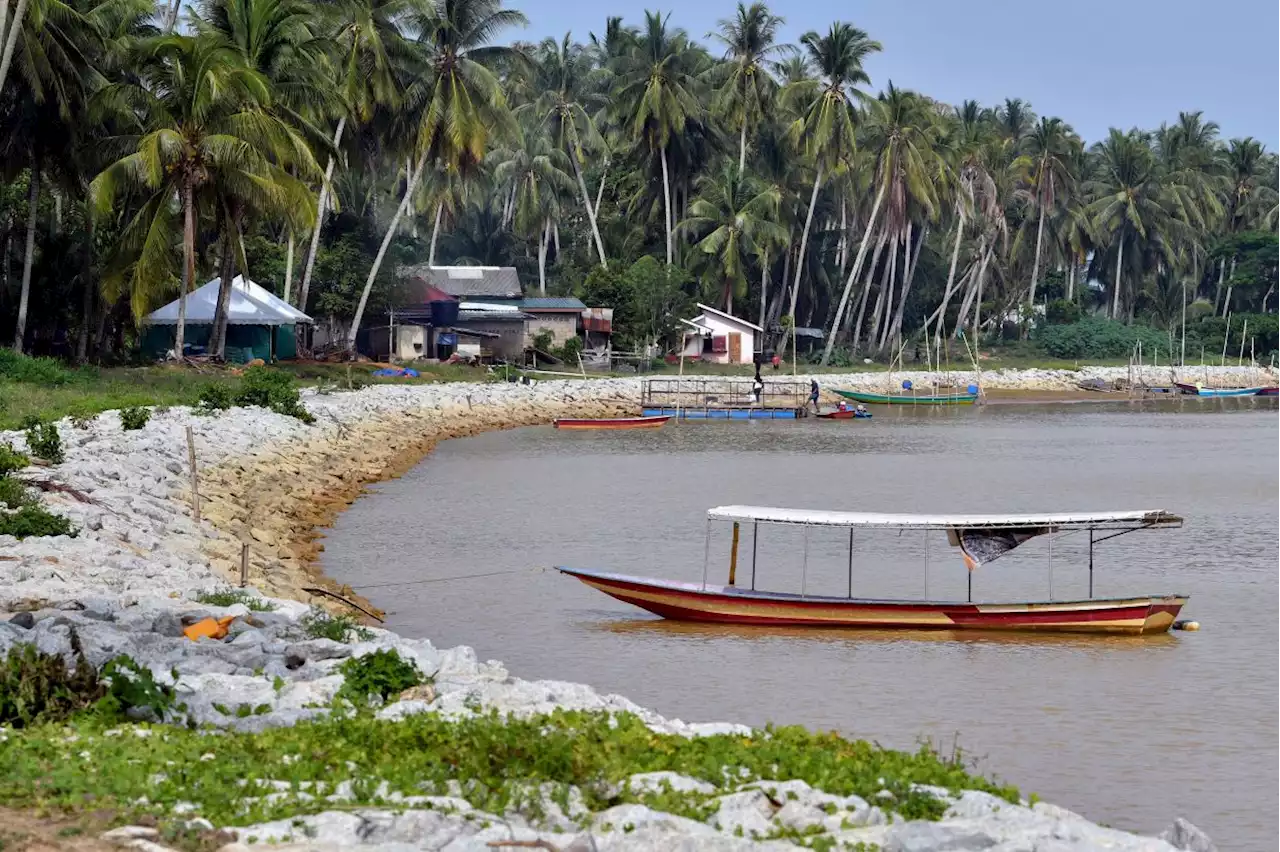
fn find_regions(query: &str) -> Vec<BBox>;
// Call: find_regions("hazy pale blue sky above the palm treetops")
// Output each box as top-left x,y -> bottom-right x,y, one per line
508,0 -> 1280,151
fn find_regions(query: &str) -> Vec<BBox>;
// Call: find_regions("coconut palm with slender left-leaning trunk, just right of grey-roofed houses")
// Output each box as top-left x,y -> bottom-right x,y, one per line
532,33 -> 609,267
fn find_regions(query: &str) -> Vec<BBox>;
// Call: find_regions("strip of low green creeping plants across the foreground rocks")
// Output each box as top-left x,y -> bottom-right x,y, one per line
0,711 -> 1018,825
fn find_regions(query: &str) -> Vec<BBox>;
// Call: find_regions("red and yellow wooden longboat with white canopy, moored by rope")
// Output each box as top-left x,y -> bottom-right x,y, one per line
558,505 -> 1187,635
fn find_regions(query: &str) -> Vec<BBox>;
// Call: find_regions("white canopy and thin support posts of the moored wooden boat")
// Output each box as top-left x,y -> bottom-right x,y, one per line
703,505 -> 1183,603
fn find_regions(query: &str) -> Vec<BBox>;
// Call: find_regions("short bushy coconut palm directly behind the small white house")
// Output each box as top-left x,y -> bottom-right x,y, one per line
680,165 -> 787,313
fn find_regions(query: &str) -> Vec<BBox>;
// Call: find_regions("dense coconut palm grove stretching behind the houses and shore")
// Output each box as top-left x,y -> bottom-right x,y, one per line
0,0 -> 1280,359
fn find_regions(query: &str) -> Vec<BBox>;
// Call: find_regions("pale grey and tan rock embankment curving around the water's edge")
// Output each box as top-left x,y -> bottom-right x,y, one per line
0,368 -> 1228,852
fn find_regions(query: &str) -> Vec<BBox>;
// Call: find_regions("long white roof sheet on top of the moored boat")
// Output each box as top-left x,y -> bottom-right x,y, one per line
707,505 -> 1183,530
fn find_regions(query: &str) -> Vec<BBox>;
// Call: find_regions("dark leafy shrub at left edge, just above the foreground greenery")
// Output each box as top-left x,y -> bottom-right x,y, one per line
0,631 -> 106,728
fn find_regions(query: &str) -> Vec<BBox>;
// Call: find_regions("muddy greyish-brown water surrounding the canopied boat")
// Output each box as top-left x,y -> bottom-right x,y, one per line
323,400 -> 1280,849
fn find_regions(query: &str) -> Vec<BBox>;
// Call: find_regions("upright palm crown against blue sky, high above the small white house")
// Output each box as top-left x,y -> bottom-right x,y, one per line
707,3 -> 795,173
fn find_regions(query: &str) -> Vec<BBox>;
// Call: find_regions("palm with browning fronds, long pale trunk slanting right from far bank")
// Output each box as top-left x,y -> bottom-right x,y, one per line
822,83 -> 938,366
